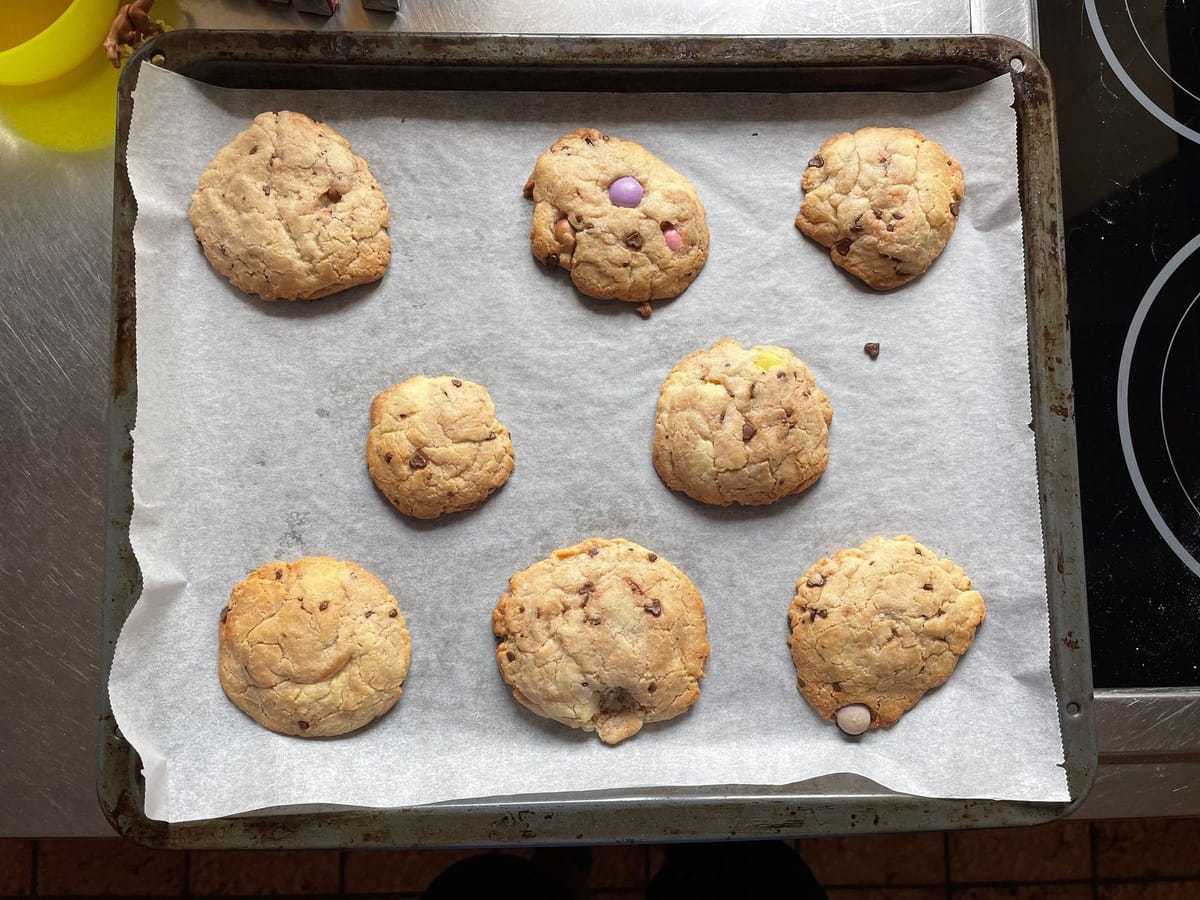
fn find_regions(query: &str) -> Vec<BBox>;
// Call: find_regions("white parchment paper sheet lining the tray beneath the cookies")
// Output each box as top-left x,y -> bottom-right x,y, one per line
109,66 -> 1068,821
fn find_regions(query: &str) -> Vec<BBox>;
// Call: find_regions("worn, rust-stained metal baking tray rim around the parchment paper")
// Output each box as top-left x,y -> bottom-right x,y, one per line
98,31 -> 1097,847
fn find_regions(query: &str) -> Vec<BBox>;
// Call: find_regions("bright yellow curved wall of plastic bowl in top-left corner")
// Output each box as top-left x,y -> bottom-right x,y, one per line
0,0 -> 120,85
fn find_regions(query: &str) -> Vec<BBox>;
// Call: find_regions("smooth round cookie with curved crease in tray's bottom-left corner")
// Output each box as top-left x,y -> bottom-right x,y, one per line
217,557 -> 409,738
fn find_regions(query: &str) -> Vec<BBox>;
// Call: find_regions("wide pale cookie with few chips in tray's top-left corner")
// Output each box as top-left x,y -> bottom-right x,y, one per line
188,110 -> 391,300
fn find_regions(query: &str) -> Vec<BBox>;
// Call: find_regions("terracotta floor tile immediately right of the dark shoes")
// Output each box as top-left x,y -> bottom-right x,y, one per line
797,832 -> 946,887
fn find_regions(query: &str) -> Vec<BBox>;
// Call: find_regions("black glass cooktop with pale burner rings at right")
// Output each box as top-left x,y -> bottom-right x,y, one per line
1038,0 -> 1200,688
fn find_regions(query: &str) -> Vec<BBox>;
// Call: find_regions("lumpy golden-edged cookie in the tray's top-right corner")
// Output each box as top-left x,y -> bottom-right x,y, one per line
796,128 -> 964,290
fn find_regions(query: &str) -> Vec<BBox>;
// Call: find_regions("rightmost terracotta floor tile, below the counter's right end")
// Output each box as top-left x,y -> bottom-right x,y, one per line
1093,818 -> 1200,878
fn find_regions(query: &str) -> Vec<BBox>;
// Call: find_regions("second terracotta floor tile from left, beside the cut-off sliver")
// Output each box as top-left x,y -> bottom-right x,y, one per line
36,838 -> 185,896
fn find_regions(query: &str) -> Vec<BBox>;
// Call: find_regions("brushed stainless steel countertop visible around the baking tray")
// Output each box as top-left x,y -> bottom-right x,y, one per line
0,0 -> 1200,836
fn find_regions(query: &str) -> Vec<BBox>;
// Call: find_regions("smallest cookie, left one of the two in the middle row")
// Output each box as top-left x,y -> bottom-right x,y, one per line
367,376 -> 512,518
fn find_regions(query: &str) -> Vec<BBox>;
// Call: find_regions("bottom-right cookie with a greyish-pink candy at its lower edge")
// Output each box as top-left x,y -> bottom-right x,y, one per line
787,535 -> 985,734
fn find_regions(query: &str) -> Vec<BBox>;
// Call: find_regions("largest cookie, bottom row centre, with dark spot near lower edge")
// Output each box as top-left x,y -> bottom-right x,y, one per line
492,538 -> 708,744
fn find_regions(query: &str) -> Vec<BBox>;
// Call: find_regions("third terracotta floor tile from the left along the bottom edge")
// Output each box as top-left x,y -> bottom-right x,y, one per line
188,850 -> 340,896
